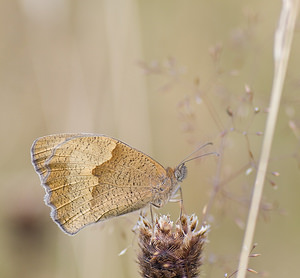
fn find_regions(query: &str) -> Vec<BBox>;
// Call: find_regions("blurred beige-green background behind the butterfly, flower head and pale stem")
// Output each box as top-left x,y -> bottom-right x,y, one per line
0,0 -> 300,278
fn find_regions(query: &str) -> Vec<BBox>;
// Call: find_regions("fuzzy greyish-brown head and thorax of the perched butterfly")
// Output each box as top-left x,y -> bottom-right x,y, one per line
151,164 -> 187,207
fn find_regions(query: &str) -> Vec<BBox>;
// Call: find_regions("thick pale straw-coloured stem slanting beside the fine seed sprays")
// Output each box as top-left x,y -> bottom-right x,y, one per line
237,0 -> 298,278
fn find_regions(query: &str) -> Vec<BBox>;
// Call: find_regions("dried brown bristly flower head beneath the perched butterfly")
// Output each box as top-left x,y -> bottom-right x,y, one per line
137,214 -> 209,278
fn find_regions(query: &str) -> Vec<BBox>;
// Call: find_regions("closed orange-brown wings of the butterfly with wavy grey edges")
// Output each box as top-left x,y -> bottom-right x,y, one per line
32,134 -> 166,234
